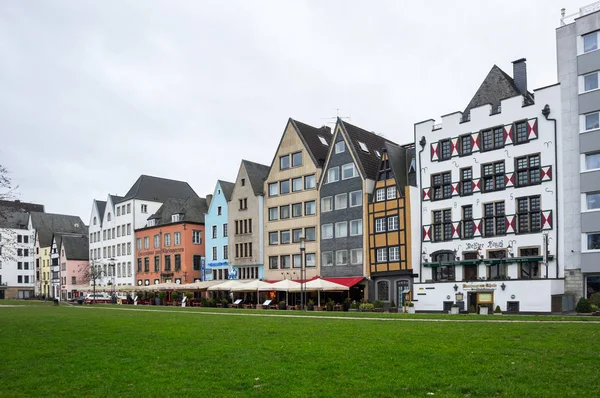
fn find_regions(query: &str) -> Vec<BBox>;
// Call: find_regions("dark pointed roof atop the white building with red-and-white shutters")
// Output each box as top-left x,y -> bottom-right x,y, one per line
463,65 -> 533,120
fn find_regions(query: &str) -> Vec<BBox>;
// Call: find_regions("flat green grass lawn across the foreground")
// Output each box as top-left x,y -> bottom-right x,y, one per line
0,301 -> 600,397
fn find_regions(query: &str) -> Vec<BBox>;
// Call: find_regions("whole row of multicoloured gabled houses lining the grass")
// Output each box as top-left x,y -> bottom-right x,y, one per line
0,10 -> 600,313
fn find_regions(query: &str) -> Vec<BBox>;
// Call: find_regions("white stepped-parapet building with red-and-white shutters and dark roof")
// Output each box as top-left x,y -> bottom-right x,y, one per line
413,59 -> 564,313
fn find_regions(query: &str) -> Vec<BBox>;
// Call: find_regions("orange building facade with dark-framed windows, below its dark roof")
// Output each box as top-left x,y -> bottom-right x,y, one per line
135,222 -> 205,286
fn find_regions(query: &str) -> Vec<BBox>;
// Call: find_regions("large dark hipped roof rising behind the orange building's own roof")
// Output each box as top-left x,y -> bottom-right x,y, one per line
118,175 -> 198,203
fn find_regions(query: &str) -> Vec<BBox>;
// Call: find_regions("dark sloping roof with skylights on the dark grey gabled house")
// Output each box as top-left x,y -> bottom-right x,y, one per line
338,118 -> 398,180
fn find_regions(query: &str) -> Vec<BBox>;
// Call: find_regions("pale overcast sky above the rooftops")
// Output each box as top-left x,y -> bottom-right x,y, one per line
0,0 -> 590,223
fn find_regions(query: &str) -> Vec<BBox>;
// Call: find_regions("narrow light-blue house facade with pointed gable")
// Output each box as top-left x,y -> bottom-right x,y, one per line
202,180 -> 237,281
